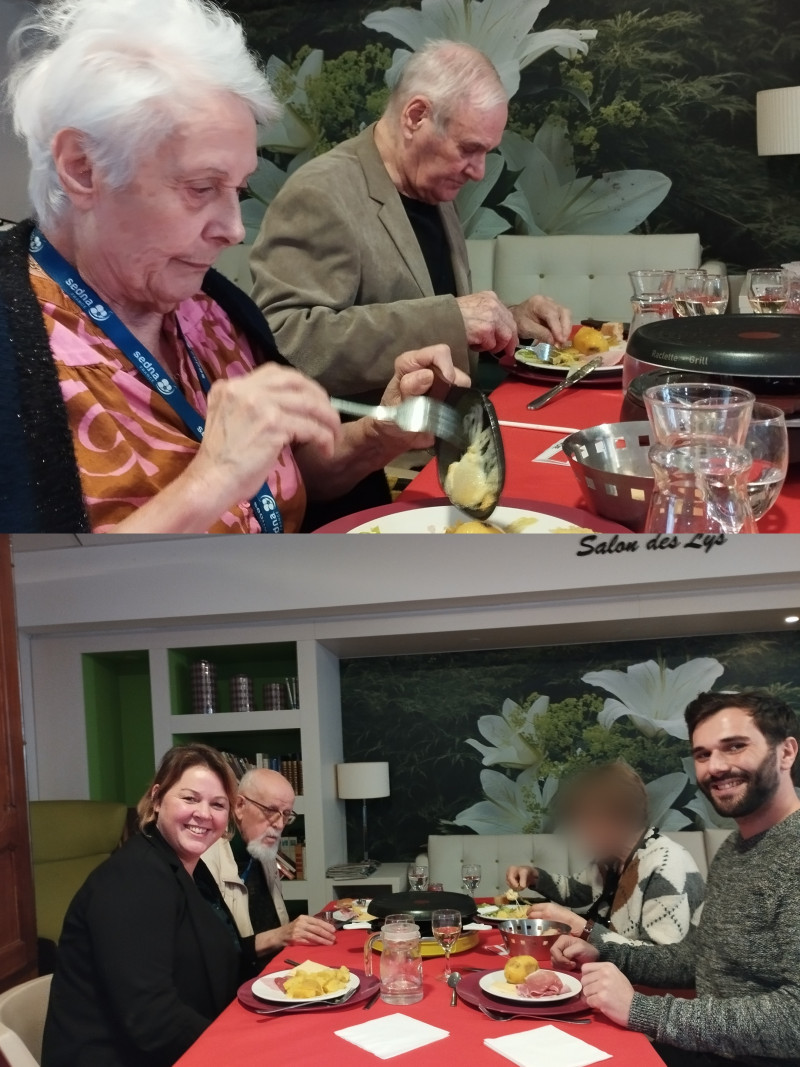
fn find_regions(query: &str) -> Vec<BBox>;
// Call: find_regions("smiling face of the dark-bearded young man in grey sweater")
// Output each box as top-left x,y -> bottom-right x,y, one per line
691,707 -> 781,818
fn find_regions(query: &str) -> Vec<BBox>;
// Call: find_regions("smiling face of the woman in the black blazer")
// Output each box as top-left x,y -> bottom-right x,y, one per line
155,766 -> 229,872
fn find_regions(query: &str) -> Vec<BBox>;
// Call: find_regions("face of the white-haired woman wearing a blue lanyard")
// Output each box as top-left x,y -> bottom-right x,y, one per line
78,94 -> 256,314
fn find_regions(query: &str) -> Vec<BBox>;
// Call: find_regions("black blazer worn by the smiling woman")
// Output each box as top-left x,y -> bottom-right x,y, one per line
42,828 -> 240,1067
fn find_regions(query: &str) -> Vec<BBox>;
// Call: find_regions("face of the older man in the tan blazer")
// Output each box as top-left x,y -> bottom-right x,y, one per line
404,103 -> 509,204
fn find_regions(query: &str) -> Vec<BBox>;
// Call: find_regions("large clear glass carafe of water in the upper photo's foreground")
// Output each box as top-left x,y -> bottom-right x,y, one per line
644,382 -> 756,534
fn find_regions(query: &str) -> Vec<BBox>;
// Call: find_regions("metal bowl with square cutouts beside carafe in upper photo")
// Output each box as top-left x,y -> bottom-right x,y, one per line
563,423 -> 655,532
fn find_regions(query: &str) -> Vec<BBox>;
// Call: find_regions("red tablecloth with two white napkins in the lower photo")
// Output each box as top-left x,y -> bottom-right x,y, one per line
178,930 -> 663,1067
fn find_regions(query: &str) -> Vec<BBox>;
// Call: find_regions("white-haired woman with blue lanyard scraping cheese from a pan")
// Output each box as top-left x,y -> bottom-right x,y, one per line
0,0 -> 466,532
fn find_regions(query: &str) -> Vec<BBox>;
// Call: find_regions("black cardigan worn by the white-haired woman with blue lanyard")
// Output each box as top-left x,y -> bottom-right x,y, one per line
0,220 -> 286,534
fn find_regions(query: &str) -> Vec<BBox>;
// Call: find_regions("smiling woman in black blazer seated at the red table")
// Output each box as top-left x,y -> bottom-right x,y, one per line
42,745 -> 249,1067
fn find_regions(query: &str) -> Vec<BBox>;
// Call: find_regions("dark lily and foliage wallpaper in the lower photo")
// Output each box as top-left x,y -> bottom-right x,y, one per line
341,632 -> 800,860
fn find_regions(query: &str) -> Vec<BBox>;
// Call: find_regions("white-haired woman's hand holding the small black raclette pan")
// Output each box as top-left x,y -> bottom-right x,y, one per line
375,345 -> 469,455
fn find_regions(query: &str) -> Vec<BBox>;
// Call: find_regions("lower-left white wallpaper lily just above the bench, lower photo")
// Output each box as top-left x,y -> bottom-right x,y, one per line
453,767 -> 559,833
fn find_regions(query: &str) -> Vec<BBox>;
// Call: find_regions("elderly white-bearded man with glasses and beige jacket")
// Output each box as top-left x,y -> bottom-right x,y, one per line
203,767 -> 336,969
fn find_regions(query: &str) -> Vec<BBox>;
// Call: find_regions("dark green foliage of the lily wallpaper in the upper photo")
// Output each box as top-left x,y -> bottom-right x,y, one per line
227,0 -> 800,269
